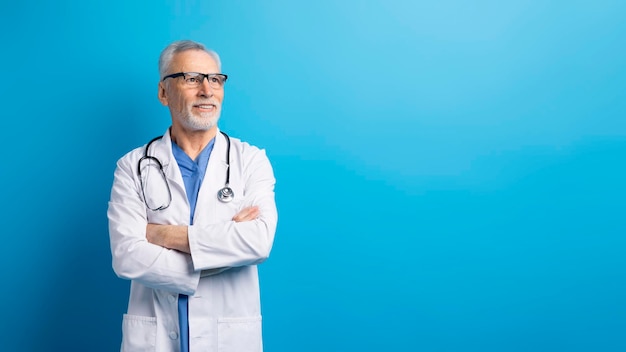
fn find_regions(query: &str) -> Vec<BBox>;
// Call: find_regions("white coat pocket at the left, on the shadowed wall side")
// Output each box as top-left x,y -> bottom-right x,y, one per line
121,314 -> 157,352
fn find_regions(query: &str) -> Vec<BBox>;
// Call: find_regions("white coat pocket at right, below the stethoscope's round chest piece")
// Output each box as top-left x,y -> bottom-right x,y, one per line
217,316 -> 263,352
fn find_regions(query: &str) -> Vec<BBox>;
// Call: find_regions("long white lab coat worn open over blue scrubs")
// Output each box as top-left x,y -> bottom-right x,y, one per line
108,130 -> 277,352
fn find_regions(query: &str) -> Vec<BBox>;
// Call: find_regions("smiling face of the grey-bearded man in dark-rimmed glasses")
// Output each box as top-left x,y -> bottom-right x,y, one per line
159,50 -> 224,133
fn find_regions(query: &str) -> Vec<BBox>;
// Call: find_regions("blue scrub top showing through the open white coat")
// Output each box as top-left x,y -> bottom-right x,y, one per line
172,138 -> 215,352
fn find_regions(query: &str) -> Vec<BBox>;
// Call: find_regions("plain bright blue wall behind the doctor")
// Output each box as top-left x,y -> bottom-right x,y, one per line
0,0 -> 626,352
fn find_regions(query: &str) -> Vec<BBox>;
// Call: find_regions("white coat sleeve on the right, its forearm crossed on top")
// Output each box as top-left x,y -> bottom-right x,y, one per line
188,147 -> 278,270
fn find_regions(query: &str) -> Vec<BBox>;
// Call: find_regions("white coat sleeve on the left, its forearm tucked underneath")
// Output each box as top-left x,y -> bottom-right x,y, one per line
107,158 -> 200,295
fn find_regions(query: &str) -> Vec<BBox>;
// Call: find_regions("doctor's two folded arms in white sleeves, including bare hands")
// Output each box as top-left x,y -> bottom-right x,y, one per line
107,144 -> 277,295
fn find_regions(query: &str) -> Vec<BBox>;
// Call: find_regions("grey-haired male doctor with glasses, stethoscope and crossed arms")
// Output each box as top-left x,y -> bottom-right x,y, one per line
108,41 -> 277,352
